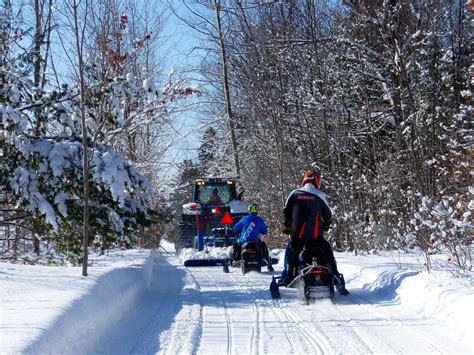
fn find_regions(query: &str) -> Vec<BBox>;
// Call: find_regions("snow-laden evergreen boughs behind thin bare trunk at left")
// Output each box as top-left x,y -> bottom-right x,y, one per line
0,45 -> 156,257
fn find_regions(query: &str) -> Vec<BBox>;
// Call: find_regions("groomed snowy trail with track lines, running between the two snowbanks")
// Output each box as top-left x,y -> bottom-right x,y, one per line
93,256 -> 472,355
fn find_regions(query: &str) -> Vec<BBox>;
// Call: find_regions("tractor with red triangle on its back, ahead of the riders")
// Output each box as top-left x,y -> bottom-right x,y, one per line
175,178 -> 250,266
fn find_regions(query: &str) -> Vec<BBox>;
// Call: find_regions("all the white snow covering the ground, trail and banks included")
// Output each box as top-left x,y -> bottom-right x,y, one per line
0,243 -> 474,354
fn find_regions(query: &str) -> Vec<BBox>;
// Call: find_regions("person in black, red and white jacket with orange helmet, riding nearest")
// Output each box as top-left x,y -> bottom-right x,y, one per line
282,167 -> 349,295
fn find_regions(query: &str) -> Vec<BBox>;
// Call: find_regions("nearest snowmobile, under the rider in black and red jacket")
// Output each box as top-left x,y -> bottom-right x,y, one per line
270,249 -> 348,304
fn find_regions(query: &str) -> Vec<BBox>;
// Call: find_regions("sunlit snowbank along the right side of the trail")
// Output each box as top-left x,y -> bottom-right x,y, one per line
335,252 -> 474,341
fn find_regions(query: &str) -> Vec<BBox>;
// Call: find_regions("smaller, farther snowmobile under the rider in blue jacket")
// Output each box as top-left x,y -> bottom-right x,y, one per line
223,242 -> 278,275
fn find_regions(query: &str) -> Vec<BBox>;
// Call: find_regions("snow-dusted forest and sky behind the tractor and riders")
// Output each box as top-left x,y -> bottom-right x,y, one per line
0,0 -> 474,270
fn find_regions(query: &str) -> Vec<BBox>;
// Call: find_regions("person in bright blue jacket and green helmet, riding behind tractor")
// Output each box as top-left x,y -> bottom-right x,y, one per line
232,204 -> 274,271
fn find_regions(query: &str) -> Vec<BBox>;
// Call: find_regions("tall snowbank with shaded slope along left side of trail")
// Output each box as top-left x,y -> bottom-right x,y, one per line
0,250 -> 154,354
